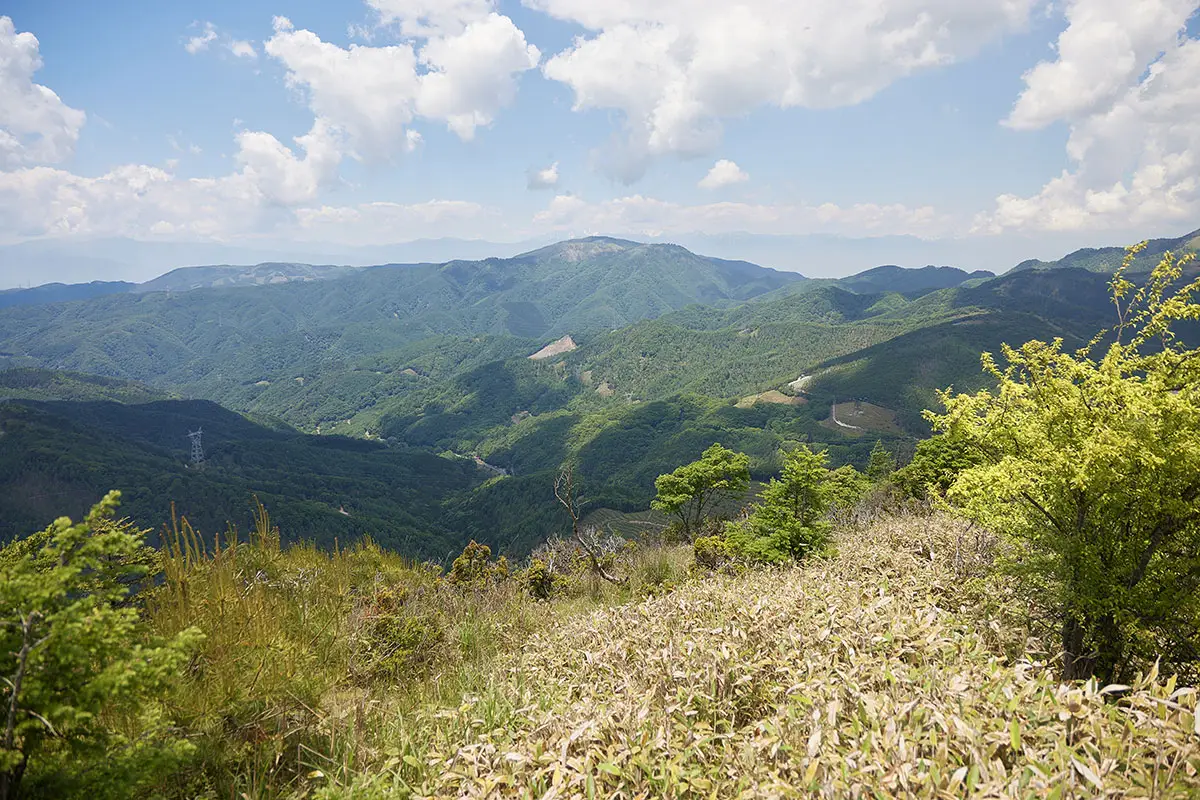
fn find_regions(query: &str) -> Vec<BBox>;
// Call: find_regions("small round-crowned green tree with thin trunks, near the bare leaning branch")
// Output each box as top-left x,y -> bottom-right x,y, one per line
650,444 -> 750,540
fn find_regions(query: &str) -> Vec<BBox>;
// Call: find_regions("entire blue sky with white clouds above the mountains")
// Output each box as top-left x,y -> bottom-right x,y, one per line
0,0 -> 1200,278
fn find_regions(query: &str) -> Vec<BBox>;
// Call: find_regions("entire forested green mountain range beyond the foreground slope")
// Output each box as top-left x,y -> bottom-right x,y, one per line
0,235 -> 1195,557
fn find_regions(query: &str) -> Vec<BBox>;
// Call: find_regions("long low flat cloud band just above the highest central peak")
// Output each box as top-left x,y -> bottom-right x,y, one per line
530,194 -> 953,236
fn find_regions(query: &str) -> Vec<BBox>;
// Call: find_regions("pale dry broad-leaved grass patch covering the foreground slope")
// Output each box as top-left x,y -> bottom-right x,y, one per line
323,517 -> 1200,798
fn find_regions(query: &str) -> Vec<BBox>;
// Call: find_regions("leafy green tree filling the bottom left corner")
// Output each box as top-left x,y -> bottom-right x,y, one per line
0,492 -> 200,800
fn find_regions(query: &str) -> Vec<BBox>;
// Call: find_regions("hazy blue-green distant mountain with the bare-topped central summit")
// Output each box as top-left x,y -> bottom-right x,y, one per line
0,239 -> 802,399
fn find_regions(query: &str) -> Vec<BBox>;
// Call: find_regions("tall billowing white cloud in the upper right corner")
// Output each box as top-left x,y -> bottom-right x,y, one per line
974,0 -> 1200,233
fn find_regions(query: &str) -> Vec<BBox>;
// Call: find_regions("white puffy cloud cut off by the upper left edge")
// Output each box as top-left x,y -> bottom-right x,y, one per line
0,17 -> 86,169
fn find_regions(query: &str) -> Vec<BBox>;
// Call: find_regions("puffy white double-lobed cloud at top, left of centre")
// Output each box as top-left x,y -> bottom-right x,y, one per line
265,9 -> 540,160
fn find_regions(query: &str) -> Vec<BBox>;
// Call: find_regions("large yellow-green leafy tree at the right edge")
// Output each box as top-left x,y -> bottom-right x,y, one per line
928,246 -> 1200,681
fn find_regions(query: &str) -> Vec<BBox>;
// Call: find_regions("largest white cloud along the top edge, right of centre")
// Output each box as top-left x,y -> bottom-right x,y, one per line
523,0 -> 1042,180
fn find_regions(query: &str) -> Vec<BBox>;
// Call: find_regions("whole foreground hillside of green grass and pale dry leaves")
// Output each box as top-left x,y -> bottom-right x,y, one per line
14,506 -> 1200,800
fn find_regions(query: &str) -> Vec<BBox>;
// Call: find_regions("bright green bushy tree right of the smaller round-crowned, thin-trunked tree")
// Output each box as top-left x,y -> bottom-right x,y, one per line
726,445 -> 830,563
